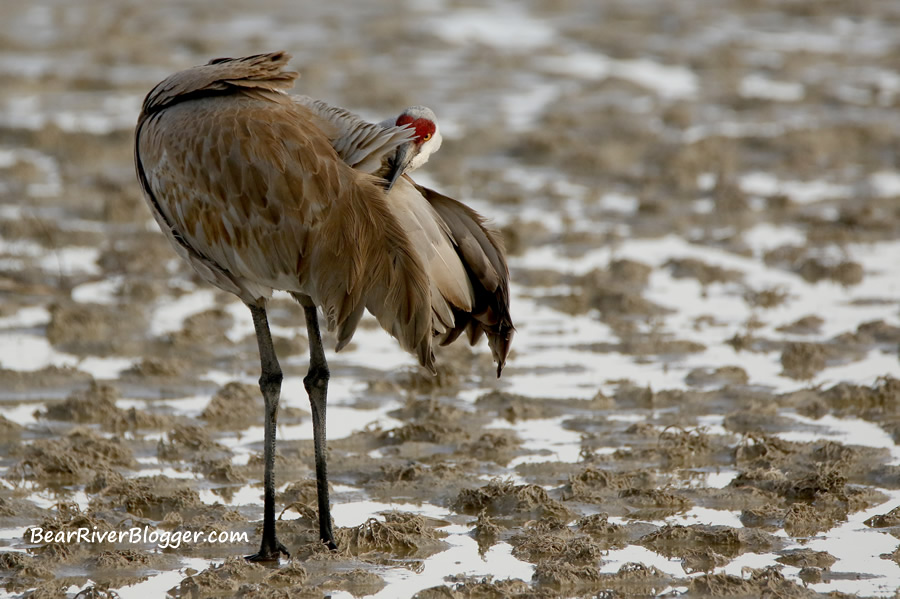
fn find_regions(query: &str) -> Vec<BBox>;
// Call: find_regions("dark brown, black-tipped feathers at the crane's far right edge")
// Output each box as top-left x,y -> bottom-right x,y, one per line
416,185 -> 515,377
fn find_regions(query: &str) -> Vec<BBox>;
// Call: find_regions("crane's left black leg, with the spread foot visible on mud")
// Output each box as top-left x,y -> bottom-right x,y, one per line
247,304 -> 291,562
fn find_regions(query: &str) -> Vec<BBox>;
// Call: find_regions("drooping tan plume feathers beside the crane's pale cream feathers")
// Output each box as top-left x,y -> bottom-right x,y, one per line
311,169 -> 435,372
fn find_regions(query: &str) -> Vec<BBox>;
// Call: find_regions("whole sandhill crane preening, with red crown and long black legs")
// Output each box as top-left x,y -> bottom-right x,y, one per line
135,52 -> 514,561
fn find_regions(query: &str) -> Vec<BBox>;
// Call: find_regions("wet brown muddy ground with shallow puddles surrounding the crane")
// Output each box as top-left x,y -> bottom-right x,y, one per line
0,0 -> 900,599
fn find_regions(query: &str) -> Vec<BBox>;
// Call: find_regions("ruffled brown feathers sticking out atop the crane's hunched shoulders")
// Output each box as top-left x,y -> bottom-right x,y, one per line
143,51 -> 299,114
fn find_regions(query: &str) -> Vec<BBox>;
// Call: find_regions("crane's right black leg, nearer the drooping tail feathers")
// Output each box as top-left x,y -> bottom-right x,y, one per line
296,296 -> 337,549
